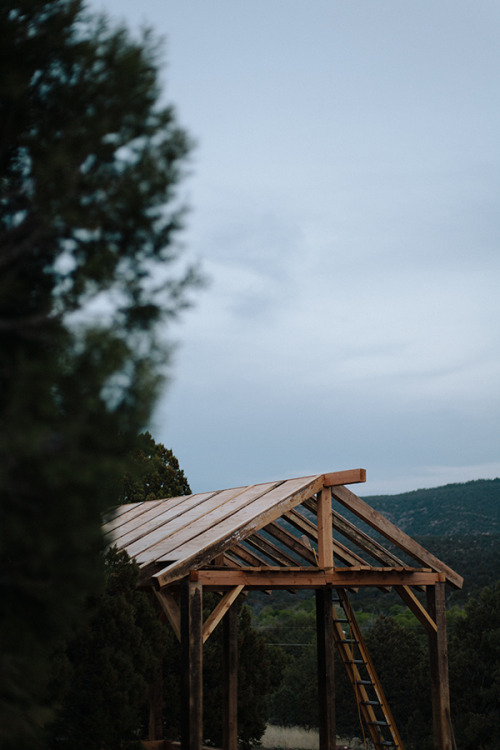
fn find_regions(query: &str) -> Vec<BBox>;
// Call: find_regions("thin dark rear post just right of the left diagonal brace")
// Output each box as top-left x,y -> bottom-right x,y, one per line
222,602 -> 238,750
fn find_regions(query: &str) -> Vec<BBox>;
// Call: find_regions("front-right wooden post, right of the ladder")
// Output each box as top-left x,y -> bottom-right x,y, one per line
427,582 -> 453,750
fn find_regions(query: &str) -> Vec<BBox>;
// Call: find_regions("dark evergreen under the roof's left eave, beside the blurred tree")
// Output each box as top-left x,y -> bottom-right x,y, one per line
50,548 -> 166,750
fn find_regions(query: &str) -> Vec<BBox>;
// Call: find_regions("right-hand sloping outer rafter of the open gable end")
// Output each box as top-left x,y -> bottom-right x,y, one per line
332,487 -> 463,589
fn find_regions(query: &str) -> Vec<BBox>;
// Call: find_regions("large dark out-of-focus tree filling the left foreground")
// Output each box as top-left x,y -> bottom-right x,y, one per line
0,0 -> 196,750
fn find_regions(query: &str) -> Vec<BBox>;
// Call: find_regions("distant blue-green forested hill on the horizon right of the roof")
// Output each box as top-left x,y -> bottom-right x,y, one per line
364,479 -> 500,537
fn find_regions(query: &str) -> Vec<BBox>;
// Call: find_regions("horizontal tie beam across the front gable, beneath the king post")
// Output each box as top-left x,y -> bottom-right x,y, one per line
195,566 -> 442,591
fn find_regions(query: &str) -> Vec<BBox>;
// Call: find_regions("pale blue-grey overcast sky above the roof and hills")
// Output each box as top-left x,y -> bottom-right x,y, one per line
91,0 -> 500,496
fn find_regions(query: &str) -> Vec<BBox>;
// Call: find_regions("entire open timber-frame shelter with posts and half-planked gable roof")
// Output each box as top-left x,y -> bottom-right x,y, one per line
105,469 -> 463,750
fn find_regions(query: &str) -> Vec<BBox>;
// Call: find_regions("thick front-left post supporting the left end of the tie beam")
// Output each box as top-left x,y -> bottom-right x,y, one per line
181,581 -> 203,750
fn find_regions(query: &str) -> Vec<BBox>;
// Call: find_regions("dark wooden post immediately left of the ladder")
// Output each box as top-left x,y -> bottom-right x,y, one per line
316,588 -> 335,750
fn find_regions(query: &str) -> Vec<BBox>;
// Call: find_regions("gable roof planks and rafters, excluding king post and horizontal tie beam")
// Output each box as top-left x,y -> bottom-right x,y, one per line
105,469 -> 463,588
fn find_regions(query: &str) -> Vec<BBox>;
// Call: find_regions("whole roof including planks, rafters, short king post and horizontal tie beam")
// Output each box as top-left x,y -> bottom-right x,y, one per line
105,469 -> 463,590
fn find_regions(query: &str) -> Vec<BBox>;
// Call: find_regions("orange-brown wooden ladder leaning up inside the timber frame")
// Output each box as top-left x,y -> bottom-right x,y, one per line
333,589 -> 404,750
